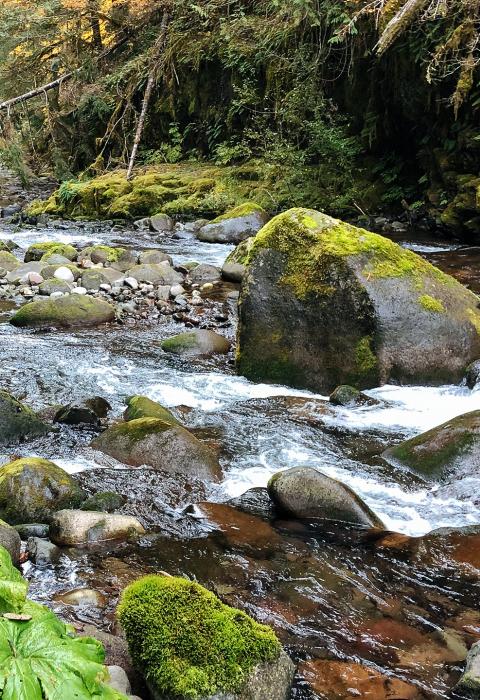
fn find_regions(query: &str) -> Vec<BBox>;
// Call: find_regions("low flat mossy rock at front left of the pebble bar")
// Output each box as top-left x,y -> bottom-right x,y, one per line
10,294 -> 115,328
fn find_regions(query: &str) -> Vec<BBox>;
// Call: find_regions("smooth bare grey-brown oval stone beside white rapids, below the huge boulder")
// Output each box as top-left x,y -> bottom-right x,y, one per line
268,467 -> 384,528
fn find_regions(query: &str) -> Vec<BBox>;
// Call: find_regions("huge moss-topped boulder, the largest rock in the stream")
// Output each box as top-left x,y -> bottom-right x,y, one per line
237,209 -> 480,392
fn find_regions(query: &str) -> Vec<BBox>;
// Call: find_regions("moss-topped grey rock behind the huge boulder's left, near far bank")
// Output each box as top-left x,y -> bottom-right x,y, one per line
196,203 -> 269,243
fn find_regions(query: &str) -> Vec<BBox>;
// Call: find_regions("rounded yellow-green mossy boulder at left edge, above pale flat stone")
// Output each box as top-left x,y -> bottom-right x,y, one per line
0,457 -> 85,524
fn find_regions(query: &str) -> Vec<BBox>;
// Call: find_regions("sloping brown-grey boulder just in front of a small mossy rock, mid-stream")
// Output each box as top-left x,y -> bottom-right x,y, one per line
92,418 -> 220,480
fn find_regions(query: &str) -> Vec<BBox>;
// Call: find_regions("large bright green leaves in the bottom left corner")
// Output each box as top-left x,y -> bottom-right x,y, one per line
0,547 -> 126,700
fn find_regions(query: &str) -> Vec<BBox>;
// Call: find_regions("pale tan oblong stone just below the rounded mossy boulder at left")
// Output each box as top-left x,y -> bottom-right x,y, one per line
50,510 -> 145,546
